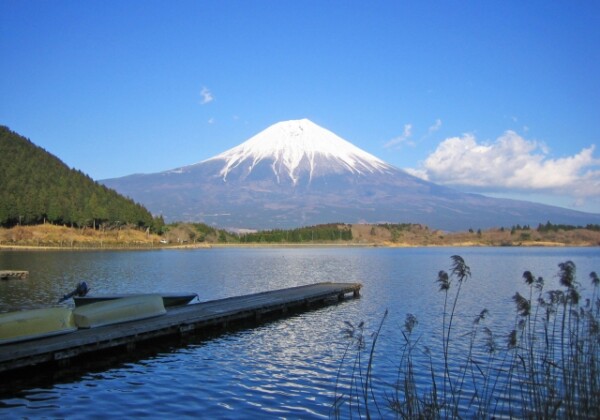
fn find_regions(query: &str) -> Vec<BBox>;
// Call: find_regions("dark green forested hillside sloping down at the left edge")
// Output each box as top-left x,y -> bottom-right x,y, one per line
0,126 -> 162,230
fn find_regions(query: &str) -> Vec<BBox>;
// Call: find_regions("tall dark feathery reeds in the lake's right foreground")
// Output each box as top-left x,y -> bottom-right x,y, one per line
331,255 -> 600,419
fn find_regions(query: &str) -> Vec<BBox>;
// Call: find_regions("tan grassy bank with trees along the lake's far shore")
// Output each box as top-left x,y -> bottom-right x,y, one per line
0,223 -> 600,249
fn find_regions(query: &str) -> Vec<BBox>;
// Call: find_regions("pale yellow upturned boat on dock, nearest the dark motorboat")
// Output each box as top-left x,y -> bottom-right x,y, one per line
73,295 -> 167,328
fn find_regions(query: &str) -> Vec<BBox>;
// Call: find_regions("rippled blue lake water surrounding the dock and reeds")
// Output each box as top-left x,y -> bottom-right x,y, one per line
0,248 -> 600,419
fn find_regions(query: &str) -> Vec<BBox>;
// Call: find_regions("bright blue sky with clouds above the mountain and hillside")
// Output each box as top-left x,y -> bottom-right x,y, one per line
0,0 -> 600,213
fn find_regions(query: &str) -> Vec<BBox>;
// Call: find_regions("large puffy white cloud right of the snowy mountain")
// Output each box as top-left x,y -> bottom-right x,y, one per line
407,131 -> 600,201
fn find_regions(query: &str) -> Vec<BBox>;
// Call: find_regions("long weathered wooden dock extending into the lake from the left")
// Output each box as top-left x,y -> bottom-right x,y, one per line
0,283 -> 362,375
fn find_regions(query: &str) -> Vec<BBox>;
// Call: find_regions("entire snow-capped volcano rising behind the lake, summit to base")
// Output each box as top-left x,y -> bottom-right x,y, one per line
100,119 -> 600,230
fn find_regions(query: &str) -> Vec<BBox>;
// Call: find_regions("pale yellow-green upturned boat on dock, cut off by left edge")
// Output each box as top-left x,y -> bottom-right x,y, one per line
0,307 -> 77,344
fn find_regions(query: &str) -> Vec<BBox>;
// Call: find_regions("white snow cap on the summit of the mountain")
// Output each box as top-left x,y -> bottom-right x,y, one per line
204,119 -> 392,184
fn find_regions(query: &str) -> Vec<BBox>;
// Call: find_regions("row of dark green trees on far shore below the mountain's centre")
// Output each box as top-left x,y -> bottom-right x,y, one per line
240,223 -> 352,243
